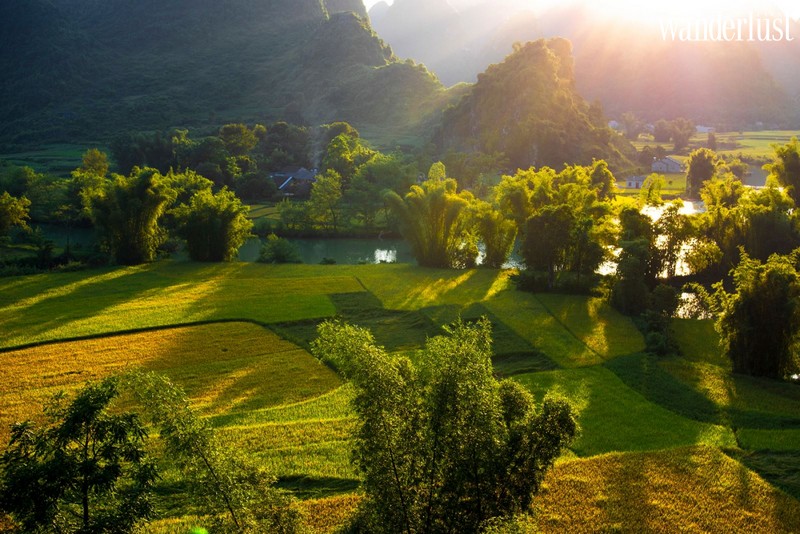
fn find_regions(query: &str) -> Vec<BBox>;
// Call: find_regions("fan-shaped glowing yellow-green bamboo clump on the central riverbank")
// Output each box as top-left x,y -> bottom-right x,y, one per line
385,178 -> 478,268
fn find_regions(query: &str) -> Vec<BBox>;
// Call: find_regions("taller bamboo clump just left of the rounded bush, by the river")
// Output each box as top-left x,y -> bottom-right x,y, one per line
89,168 -> 175,265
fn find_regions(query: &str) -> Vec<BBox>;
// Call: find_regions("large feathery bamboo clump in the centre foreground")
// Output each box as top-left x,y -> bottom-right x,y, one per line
312,319 -> 577,534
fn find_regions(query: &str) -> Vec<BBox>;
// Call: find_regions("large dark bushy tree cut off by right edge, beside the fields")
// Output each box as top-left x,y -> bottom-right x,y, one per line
717,252 -> 800,379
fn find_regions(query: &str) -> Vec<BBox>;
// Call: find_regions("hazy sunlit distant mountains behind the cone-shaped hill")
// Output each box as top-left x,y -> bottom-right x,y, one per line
369,0 -> 800,129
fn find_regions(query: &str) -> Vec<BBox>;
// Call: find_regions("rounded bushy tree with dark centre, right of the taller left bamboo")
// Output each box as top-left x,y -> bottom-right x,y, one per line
173,188 -> 253,261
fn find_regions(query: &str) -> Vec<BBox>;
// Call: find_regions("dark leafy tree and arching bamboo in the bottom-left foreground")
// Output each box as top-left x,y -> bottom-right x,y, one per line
0,372 -> 299,534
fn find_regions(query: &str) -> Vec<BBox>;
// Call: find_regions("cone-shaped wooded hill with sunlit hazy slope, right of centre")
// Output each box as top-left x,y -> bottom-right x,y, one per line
436,39 -> 633,169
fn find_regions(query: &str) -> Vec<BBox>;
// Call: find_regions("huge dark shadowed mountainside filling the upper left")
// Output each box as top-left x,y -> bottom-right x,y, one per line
0,0 -> 449,146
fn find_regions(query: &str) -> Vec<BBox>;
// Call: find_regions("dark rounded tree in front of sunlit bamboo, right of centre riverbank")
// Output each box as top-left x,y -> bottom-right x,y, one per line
522,204 -> 575,289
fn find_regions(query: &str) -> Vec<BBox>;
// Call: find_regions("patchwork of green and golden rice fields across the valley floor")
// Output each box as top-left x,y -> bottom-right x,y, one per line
0,261 -> 800,533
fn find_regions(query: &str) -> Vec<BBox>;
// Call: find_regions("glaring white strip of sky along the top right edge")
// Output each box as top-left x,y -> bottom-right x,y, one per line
364,0 -> 800,21
